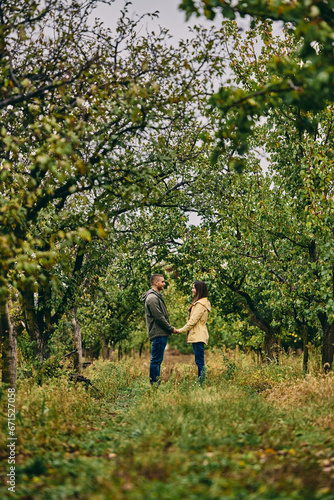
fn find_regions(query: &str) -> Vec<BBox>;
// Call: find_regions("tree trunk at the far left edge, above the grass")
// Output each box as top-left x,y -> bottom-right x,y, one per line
0,298 -> 17,387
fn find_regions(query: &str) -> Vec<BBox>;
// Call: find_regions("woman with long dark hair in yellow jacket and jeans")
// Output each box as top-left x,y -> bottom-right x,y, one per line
177,281 -> 211,382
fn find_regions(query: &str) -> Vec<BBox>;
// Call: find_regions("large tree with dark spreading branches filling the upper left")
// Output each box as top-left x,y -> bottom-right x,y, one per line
0,0 -> 228,384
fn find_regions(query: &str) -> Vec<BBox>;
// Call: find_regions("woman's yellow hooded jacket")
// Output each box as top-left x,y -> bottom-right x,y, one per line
179,297 -> 211,344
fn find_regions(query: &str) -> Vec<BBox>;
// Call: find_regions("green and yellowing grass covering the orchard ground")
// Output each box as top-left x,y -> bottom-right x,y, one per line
0,351 -> 334,500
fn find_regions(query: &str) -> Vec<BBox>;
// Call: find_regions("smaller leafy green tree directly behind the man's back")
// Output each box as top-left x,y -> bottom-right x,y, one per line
77,208 -> 187,360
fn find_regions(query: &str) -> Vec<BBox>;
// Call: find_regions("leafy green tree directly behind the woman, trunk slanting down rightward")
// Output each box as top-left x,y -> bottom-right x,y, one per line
173,162 -> 285,360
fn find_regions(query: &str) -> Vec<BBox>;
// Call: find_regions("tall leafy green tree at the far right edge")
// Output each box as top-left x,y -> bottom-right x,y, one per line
223,20 -> 334,367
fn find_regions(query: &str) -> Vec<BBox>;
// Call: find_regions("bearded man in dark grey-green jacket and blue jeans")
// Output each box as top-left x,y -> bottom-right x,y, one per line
143,274 -> 176,385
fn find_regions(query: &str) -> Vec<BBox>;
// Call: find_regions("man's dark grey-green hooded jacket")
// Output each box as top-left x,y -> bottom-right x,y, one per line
142,288 -> 174,340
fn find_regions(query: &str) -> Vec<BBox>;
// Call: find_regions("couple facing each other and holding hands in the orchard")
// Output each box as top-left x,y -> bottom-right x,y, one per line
143,274 -> 211,384
